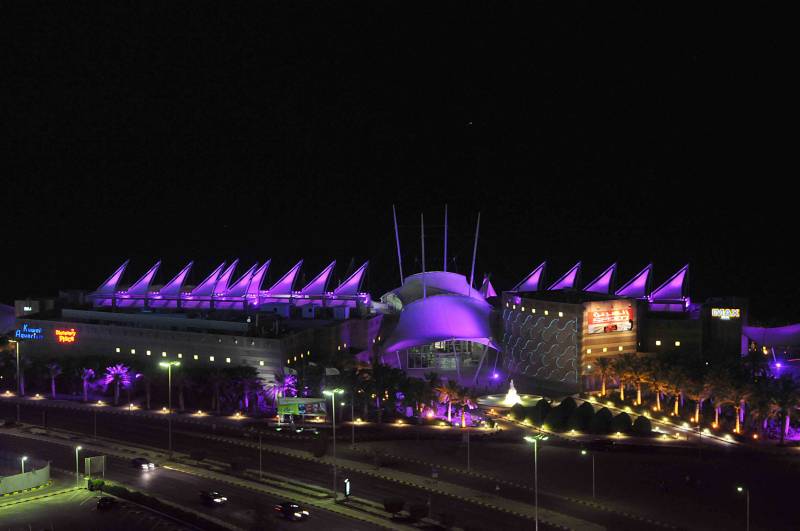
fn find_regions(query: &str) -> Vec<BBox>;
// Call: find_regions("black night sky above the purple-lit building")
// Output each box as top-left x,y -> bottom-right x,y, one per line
0,1 -> 800,324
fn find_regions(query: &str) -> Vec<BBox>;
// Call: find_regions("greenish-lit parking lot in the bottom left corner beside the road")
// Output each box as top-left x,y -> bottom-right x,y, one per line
0,490 -> 190,531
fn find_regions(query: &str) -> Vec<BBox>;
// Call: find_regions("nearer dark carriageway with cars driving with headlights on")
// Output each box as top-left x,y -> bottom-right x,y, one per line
0,432 -> 378,531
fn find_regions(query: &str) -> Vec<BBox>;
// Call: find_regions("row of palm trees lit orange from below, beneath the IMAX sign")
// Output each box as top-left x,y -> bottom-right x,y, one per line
593,350 -> 800,444
